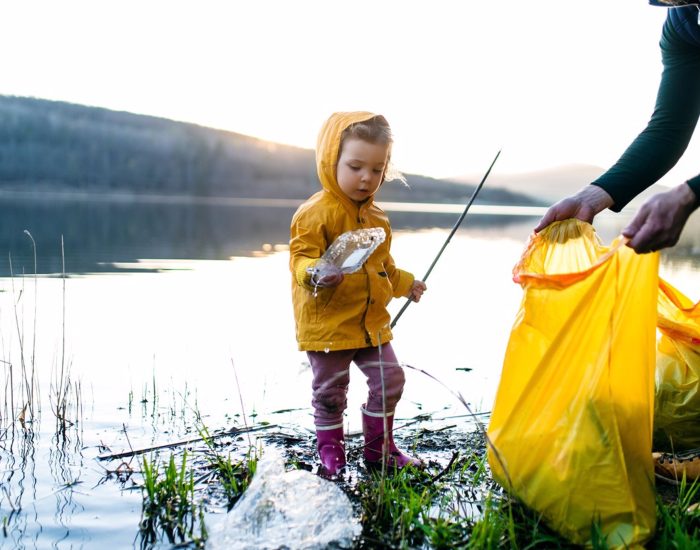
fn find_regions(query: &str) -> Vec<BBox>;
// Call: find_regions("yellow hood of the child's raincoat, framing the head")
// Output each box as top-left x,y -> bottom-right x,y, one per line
316,111 -> 377,210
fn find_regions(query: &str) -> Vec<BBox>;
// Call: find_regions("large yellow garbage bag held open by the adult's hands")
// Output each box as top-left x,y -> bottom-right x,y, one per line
488,220 -> 658,547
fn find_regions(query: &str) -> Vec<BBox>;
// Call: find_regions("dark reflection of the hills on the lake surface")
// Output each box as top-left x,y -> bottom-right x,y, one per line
0,199 -> 548,275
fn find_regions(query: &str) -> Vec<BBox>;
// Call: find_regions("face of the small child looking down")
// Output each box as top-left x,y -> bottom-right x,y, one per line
336,138 -> 389,202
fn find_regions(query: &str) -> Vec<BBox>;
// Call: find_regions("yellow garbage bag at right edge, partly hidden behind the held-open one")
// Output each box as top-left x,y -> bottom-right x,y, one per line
654,280 -> 700,451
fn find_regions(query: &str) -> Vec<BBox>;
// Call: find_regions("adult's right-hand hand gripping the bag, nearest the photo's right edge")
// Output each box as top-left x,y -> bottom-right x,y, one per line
622,183 -> 697,254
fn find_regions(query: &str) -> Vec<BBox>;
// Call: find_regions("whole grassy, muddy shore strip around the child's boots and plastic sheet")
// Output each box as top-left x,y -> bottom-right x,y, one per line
126,402 -> 700,550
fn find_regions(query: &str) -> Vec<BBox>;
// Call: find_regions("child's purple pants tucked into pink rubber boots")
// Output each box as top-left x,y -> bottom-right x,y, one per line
306,343 -> 405,428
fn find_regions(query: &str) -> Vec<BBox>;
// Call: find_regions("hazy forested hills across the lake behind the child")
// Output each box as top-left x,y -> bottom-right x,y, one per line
0,96 -> 540,205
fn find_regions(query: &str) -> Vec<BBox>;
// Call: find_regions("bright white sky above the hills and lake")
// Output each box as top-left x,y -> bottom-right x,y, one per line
0,0 -> 700,183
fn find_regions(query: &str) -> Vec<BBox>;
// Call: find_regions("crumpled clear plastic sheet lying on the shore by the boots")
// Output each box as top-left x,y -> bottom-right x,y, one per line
207,447 -> 361,550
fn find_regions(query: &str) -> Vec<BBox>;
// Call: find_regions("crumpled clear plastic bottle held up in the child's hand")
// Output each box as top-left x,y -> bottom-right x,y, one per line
308,227 -> 386,281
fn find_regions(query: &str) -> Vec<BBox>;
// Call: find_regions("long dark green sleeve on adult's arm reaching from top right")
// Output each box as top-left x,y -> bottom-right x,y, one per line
593,19 -> 700,212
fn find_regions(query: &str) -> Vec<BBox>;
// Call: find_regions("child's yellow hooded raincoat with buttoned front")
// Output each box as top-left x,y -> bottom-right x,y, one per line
289,112 -> 414,351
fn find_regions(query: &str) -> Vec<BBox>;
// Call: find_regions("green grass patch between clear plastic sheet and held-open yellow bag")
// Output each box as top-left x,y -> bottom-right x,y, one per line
358,444 -> 570,549
